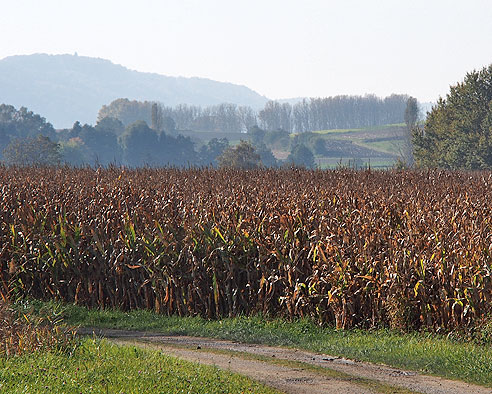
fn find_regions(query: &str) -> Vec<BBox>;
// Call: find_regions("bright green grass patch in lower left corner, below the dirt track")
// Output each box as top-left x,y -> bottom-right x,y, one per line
0,339 -> 278,394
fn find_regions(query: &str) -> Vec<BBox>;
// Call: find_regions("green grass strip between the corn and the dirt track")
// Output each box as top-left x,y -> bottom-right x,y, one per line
64,306 -> 492,387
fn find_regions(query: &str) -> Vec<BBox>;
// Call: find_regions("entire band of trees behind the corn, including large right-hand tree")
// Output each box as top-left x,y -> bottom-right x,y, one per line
0,58 -> 492,170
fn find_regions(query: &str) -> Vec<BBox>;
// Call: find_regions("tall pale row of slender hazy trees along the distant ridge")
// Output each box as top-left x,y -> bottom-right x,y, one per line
98,94 -> 409,133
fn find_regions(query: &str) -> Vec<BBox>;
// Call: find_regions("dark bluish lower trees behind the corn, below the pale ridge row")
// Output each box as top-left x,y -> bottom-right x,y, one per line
0,104 -> 296,168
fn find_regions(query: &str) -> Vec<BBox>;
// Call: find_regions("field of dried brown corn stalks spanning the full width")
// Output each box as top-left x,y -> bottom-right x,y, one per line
0,167 -> 492,330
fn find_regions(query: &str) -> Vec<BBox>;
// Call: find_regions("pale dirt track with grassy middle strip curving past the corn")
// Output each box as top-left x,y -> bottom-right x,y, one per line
79,328 -> 492,394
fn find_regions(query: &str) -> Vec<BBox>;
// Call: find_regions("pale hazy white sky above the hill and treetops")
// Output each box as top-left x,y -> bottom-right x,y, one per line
0,0 -> 492,101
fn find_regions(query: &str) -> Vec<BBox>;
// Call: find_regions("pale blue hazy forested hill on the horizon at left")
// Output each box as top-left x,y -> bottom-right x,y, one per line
0,54 -> 267,128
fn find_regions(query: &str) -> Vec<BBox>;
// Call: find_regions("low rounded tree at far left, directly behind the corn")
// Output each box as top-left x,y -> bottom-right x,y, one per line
3,134 -> 61,166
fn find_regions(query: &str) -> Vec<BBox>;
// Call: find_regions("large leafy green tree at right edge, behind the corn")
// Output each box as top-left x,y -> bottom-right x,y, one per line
413,65 -> 492,169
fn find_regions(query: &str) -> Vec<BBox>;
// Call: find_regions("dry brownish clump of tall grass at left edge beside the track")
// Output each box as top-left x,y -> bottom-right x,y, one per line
0,301 -> 77,357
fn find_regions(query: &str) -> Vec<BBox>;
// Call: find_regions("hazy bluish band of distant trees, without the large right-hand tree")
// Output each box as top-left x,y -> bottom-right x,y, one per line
0,91 -> 416,167
